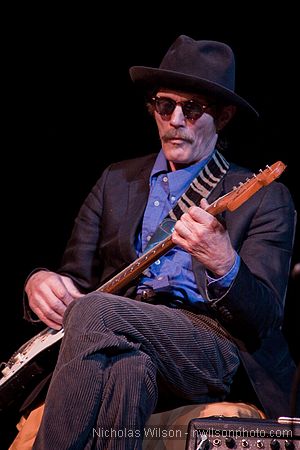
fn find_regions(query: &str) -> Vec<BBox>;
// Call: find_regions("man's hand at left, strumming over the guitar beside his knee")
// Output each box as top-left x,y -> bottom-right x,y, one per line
25,270 -> 83,330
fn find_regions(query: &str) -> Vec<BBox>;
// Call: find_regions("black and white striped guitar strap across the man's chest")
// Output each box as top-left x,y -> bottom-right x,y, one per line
145,150 -> 229,251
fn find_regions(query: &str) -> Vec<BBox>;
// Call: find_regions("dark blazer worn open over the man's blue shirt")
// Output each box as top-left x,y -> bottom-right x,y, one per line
60,154 -> 295,418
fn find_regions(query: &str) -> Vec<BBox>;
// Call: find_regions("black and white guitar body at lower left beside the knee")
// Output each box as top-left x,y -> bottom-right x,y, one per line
0,328 -> 64,412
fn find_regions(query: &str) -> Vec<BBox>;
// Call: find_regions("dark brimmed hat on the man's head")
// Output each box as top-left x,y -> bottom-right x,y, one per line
129,35 -> 258,116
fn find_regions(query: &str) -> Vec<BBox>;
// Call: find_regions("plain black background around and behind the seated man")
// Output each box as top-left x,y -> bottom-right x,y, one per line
0,3 -> 300,446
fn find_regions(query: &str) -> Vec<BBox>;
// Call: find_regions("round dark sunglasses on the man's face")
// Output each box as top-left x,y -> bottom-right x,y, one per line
151,96 -> 212,121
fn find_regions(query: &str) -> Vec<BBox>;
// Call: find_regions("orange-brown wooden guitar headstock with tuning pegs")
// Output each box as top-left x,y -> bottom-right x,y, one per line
207,161 -> 286,215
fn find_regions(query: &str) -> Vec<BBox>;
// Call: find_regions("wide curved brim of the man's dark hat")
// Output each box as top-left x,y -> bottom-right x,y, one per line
129,66 -> 259,117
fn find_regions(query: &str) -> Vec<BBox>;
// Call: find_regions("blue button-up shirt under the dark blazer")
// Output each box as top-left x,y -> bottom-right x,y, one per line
136,150 -> 240,306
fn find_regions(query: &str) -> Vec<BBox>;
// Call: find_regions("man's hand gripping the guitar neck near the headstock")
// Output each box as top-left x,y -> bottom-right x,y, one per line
172,199 -> 235,277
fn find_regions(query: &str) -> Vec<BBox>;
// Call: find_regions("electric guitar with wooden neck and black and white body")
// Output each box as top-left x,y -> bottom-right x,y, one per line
0,161 -> 286,411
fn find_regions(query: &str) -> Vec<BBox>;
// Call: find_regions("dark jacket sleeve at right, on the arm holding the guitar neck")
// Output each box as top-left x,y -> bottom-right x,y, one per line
199,182 -> 296,339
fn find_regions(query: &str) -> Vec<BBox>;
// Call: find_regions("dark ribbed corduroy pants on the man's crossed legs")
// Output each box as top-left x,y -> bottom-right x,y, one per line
33,292 -> 239,450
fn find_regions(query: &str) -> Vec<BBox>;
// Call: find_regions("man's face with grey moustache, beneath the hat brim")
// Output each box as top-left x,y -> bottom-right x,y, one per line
154,89 -> 217,170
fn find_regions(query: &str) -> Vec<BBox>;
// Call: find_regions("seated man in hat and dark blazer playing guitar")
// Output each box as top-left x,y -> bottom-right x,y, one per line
26,36 -> 294,450
